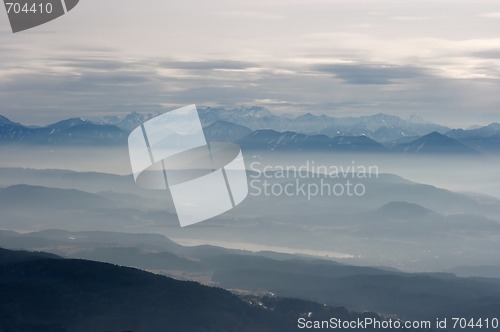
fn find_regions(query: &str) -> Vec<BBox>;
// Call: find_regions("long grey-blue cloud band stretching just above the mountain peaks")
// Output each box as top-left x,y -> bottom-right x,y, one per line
0,58 -> 500,124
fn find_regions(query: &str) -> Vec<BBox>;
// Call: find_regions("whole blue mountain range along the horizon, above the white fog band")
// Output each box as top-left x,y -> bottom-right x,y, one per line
0,106 -> 500,154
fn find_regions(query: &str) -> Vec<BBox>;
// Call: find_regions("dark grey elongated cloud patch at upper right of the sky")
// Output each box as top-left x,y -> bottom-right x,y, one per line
313,64 -> 425,84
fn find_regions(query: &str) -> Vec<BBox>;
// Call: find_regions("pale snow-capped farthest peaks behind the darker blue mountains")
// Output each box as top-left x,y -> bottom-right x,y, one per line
96,106 -> 450,143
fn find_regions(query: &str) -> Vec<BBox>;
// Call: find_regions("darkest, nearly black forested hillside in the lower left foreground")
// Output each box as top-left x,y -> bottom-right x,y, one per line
0,248 -> 394,332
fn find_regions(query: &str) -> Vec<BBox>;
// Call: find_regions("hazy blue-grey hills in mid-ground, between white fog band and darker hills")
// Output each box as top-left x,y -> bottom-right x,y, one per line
0,168 -> 500,271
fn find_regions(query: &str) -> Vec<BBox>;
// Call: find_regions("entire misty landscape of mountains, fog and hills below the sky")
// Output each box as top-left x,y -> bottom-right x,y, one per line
0,107 -> 500,332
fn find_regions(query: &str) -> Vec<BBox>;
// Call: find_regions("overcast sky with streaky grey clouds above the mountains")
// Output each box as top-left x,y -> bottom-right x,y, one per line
0,0 -> 500,127
